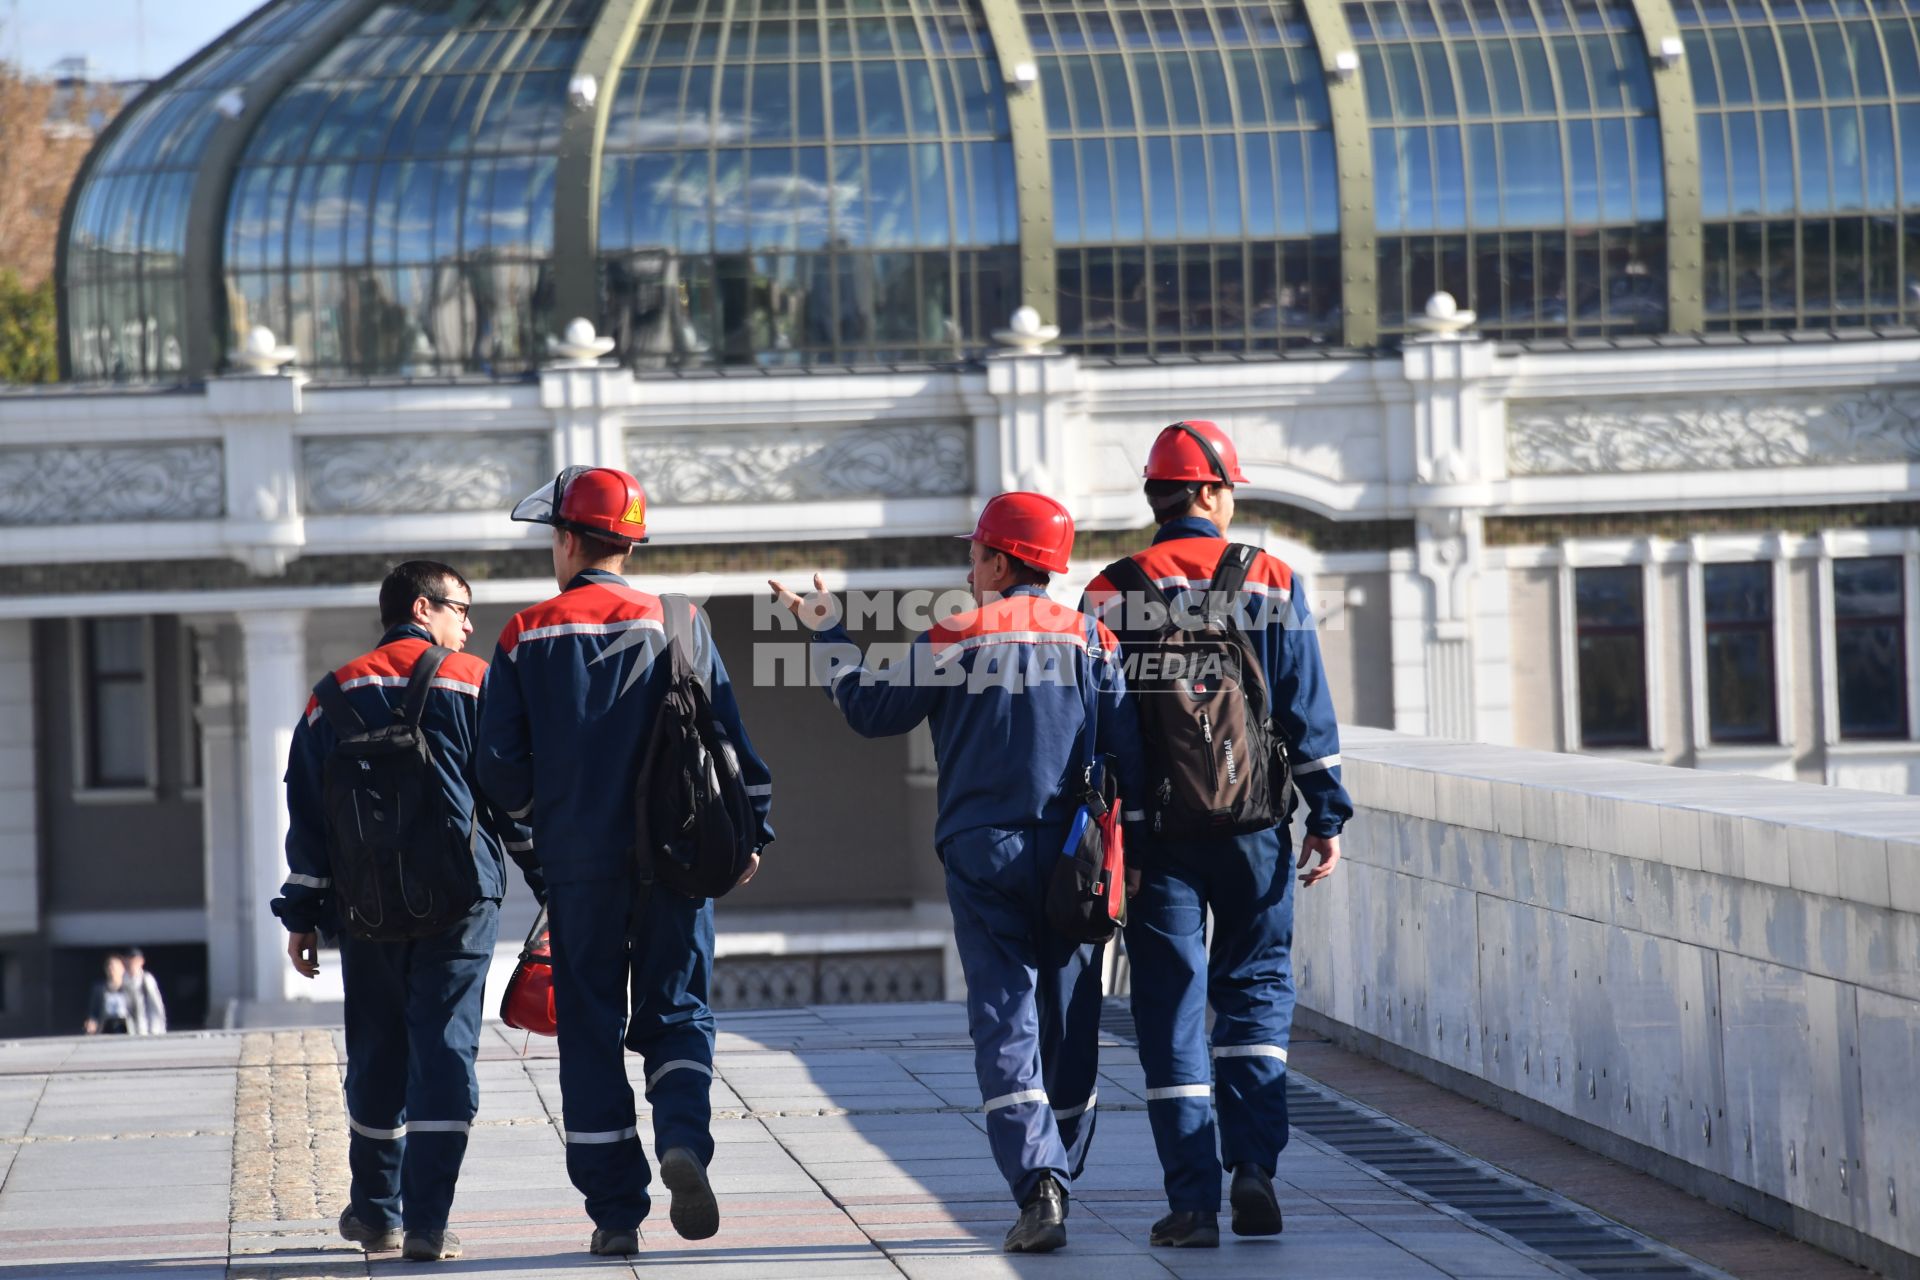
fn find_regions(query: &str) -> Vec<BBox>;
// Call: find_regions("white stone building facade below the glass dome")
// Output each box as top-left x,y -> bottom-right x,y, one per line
0,338 -> 1920,1028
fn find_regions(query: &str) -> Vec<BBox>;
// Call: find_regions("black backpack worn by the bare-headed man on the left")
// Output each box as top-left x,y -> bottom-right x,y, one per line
313,645 -> 480,942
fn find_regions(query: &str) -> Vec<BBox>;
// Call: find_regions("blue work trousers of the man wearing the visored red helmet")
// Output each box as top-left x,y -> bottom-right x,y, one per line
547,877 -> 714,1230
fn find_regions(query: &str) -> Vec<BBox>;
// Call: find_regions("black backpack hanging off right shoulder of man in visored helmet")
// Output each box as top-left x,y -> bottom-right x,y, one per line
634,595 -> 760,898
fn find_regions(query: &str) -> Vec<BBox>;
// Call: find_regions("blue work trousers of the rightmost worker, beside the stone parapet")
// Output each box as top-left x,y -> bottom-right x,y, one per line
1127,829 -> 1294,1211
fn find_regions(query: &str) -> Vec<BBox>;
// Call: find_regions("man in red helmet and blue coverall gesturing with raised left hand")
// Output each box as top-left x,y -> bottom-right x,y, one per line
770,493 -> 1140,1253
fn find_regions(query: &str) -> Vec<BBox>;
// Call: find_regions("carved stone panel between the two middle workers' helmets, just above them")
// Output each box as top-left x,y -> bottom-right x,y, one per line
626,422 -> 973,503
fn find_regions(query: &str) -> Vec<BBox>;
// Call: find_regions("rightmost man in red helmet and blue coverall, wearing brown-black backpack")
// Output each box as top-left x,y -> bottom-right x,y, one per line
1081,420 -> 1354,1247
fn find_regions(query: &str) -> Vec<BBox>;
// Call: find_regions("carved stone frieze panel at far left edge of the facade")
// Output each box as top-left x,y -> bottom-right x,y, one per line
0,441 -> 227,526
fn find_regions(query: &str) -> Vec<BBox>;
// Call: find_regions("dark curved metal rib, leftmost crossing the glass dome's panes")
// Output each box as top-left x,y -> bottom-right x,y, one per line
180,0 -> 391,378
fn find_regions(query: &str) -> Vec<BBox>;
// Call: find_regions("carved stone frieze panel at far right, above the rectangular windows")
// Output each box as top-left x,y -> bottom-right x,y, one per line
1507,386 -> 1920,476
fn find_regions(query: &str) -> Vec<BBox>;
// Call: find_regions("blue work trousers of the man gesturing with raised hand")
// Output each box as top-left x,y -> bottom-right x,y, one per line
941,823 -> 1102,1203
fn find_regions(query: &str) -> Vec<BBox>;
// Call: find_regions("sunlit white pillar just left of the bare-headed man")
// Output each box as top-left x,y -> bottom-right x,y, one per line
240,608 -> 309,1002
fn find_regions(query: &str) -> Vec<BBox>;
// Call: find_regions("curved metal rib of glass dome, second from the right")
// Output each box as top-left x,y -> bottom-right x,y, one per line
1302,0 -> 1380,347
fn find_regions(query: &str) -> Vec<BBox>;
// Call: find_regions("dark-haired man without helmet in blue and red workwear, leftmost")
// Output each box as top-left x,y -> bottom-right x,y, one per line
273,560 -> 545,1261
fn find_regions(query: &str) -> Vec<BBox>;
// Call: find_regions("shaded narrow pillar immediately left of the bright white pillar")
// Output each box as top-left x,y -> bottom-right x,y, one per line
182,614 -> 245,1027
